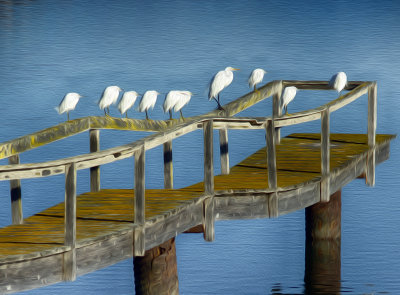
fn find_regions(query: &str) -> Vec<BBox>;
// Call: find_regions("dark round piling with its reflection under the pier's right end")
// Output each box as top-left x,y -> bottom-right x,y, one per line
304,190 -> 342,294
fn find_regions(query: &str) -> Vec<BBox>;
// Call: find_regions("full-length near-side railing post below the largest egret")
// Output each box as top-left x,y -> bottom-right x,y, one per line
203,120 -> 215,242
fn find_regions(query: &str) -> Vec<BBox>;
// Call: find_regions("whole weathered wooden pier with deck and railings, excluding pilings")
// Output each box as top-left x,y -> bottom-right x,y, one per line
0,81 -> 394,293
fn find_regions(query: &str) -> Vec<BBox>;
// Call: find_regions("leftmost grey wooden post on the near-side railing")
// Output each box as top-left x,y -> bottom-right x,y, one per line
63,163 -> 76,281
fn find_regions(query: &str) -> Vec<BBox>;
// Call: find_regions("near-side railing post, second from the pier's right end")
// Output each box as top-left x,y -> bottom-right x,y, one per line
321,107 -> 331,202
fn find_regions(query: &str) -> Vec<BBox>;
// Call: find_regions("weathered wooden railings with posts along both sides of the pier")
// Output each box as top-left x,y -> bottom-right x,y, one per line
0,81 -> 377,279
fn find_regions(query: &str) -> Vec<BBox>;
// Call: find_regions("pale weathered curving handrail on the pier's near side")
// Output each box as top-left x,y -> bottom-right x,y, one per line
0,81 -> 374,181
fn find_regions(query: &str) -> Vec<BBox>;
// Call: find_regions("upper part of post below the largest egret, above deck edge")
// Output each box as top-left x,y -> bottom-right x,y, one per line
203,120 -> 214,195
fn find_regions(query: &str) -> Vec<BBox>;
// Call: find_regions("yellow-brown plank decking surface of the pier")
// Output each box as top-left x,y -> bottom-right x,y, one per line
0,134 -> 393,265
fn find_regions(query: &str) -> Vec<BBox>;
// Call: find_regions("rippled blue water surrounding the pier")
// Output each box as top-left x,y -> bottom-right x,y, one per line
0,0 -> 400,294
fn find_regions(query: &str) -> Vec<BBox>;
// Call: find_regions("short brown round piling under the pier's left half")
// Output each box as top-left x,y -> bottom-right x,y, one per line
133,238 -> 179,295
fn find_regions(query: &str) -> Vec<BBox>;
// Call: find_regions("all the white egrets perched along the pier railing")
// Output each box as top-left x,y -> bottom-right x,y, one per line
56,67 -> 347,121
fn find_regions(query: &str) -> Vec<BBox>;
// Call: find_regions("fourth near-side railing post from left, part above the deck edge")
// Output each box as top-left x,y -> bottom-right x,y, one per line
265,120 -> 278,189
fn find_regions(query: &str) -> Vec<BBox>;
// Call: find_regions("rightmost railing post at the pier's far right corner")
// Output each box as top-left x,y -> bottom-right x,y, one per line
365,82 -> 377,186
